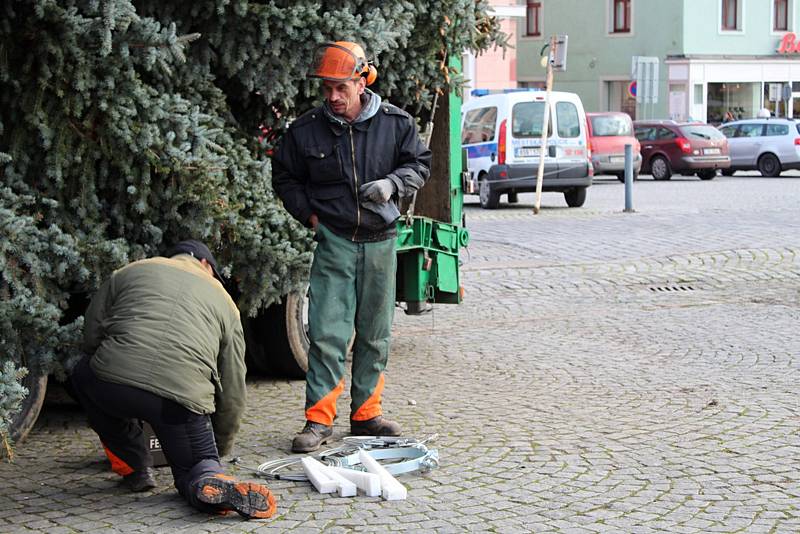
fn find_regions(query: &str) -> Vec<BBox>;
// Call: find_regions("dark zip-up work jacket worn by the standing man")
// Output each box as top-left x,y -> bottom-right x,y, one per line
272,102 -> 431,241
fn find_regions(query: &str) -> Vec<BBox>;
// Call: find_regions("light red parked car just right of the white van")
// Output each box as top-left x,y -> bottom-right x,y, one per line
586,111 -> 642,182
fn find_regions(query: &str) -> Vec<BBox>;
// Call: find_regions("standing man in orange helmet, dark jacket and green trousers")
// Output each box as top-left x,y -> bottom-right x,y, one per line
272,41 -> 431,452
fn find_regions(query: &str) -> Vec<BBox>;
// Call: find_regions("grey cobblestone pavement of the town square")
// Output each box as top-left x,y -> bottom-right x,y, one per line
0,174 -> 800,533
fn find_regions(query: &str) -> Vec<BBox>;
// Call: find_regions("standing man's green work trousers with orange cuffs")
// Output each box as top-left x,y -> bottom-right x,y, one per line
306,224 -> 397,425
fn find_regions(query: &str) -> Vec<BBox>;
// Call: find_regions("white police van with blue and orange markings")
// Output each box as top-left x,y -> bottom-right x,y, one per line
461,91 -> 592,209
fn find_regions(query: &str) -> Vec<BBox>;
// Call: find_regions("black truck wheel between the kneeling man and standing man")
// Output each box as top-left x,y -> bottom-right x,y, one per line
243,291 -> 309,380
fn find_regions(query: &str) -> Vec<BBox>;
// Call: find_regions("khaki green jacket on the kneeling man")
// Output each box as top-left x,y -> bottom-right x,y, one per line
84,254 -> 246,456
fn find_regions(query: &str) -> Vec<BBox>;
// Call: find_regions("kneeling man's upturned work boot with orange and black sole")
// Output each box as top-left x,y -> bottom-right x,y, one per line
195,473 -> 277,519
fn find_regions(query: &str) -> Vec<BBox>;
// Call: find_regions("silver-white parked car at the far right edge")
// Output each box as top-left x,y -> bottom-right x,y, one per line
719,119 -> 800,176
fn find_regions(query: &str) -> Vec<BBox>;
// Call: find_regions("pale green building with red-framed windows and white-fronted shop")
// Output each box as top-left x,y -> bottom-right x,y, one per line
517,0 -> 800,123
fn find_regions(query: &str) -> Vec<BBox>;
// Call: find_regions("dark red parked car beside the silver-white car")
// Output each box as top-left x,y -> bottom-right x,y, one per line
633,121 -> 731,180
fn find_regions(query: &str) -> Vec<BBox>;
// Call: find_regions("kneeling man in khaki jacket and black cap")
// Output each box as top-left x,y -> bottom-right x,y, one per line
72,240 -> 275,518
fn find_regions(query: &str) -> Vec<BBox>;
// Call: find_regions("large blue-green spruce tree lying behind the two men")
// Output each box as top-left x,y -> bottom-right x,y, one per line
0,0 -> 505,448
